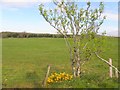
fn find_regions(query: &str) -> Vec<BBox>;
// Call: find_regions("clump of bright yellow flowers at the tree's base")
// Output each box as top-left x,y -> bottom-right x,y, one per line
47,72 -> 73,84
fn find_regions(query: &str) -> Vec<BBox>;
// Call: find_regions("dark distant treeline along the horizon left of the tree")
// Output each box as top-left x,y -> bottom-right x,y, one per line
0,32 -> 69,38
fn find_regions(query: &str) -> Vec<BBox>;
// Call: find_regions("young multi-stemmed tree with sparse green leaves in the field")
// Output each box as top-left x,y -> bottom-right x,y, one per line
39,0 -> 105,77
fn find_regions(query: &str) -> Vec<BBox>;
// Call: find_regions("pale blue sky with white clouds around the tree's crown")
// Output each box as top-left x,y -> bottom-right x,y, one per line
0,0 -> 118,36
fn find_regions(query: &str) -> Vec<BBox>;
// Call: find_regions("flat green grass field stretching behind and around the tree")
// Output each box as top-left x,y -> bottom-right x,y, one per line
2,38 -> 118,88
